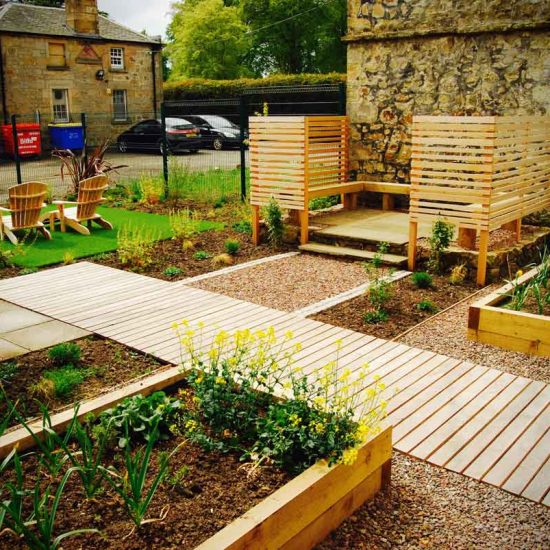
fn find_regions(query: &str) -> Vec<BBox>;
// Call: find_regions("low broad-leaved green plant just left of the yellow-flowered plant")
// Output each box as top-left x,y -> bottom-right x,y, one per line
92,391 -> 181,448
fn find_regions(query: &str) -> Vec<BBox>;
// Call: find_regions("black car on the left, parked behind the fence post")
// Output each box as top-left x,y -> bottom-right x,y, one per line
117,117 -> 205,153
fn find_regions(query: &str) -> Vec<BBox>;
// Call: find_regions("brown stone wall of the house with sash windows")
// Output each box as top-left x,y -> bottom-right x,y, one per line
1,35 -> 162,141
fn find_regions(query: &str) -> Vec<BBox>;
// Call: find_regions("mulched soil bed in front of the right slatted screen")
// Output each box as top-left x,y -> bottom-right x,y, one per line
312,276 -> 476,339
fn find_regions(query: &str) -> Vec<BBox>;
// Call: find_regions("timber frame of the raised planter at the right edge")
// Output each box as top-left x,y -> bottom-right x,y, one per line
468,268 -> 550,357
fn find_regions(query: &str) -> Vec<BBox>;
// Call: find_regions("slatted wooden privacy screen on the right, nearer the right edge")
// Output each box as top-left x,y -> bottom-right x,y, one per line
409,116 -> 550,284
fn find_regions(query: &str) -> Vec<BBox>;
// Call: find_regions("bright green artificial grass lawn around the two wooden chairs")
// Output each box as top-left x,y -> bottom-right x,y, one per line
0,207 -> 224,267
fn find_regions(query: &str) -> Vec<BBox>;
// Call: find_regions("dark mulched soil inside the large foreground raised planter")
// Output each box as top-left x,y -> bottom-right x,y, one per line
0,437 -> 289,550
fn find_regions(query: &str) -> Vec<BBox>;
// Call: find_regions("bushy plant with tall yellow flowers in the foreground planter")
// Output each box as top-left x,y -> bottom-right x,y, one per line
175,322 -> 386,472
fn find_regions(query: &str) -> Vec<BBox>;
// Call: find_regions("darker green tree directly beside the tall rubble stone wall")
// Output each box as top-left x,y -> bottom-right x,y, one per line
240,0 -> 346,74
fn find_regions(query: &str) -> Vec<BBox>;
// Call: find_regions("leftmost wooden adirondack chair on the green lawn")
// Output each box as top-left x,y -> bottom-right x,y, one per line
0,181 -> 52,244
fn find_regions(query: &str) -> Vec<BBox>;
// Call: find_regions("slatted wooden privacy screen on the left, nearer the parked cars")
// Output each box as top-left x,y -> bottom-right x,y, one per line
249,116 -> 349,244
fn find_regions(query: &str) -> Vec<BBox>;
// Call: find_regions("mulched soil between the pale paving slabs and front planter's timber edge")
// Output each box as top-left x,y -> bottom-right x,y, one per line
0,337 -> 163,426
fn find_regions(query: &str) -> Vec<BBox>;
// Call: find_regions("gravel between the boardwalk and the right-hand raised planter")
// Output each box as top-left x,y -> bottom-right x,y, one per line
399,285 -> 550,383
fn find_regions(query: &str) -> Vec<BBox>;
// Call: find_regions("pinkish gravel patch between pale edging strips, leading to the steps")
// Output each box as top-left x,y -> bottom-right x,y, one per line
191,254 -> 380,311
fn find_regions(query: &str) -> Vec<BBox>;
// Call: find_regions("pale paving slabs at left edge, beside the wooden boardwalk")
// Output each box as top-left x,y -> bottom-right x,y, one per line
0,300 -> 91,361
